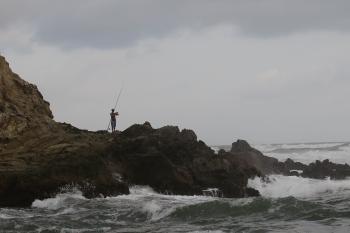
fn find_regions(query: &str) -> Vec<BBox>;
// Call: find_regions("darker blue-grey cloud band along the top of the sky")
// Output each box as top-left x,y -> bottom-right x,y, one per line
0,0 -> 350,48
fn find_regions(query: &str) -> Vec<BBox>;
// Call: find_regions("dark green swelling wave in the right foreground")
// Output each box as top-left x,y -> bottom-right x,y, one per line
169,194 -> 350,224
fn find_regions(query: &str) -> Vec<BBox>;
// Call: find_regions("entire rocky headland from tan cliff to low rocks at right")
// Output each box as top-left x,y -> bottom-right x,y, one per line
0,56 -> 350,207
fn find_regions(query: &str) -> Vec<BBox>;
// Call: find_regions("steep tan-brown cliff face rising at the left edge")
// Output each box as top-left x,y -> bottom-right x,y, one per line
0,56 -> 54,142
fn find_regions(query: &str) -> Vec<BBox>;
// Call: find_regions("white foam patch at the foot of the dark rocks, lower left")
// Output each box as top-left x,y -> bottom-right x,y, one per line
32,191 -> 86,210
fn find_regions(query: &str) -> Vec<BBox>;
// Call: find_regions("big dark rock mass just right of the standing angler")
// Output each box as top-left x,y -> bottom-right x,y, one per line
109,123 -> 260,197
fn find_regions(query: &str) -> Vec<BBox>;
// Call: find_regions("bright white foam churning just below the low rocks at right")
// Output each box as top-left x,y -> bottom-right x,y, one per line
248,175 -> 350,198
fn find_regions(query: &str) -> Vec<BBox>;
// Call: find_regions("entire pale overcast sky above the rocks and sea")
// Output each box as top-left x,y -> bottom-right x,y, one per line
0,0 -> 350,145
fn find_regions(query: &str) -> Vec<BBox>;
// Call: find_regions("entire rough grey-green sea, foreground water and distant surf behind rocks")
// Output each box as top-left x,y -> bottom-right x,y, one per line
0,142 -> 350,233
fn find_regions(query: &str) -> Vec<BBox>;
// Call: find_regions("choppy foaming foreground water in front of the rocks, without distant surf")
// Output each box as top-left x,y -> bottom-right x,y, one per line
0,184 -> 350,233
